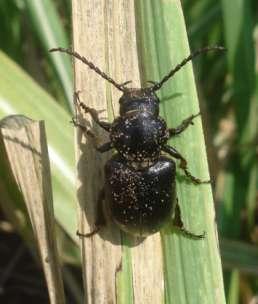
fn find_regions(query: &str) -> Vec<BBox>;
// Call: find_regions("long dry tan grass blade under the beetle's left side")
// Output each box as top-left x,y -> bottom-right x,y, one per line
73,0 -> 164,304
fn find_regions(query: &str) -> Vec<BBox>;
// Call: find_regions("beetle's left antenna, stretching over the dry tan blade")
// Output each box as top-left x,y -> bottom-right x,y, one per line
49,47 -> 126,92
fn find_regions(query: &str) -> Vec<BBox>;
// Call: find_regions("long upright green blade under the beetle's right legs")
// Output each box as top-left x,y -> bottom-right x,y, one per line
136,0 -> 225,304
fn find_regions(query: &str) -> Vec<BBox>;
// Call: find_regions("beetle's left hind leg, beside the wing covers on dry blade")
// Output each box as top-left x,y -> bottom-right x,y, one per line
76,188 -> 106,238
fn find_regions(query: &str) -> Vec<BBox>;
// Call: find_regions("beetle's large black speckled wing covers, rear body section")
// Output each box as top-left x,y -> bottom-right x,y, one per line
105,154 -> 176,237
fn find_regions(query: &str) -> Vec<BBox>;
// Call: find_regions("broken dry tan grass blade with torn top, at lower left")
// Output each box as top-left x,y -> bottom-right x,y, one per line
0,115 -> 65,304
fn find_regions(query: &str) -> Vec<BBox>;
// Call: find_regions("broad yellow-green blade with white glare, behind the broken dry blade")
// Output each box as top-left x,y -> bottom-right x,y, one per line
0,52 -> 76,240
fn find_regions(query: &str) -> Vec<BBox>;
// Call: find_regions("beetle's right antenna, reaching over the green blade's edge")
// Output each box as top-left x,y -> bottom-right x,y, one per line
149,46 -> 226,91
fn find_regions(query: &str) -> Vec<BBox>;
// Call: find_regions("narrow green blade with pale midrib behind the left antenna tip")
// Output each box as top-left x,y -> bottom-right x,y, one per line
25,0 -> 73,112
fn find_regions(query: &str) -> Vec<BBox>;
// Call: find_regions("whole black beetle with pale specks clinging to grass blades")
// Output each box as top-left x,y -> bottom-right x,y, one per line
50,46 -> 224,238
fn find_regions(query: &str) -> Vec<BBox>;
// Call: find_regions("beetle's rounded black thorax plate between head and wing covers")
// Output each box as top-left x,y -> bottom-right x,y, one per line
110,110 -> 169,162
